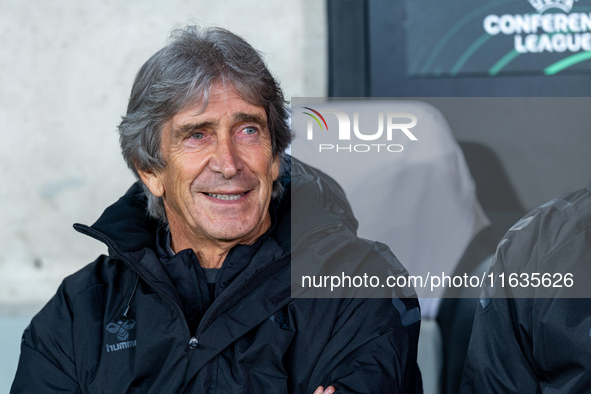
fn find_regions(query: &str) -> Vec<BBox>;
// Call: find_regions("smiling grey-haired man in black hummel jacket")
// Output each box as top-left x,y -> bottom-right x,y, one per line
12,27 -> 421,394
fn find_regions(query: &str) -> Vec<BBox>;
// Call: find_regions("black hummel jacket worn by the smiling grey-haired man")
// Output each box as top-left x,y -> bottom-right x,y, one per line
11,160 -> 421,394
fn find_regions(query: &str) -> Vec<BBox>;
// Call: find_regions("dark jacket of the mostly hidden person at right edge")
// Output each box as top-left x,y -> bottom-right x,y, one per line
460,179 -> 591,393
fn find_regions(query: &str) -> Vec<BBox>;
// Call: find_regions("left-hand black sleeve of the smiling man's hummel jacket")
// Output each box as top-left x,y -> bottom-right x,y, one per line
10,283 -> 81,394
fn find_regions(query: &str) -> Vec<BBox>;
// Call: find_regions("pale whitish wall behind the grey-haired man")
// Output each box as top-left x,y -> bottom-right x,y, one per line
0,0 -> 327,306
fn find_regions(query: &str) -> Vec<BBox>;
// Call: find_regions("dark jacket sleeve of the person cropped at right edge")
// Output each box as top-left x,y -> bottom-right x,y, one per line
460,205 -> 549,394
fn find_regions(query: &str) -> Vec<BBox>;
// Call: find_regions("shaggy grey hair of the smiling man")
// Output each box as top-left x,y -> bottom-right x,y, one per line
118,26 -> 293,223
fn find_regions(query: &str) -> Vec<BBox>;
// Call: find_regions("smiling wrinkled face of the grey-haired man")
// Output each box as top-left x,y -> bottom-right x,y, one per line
148,84 -> 279,243
